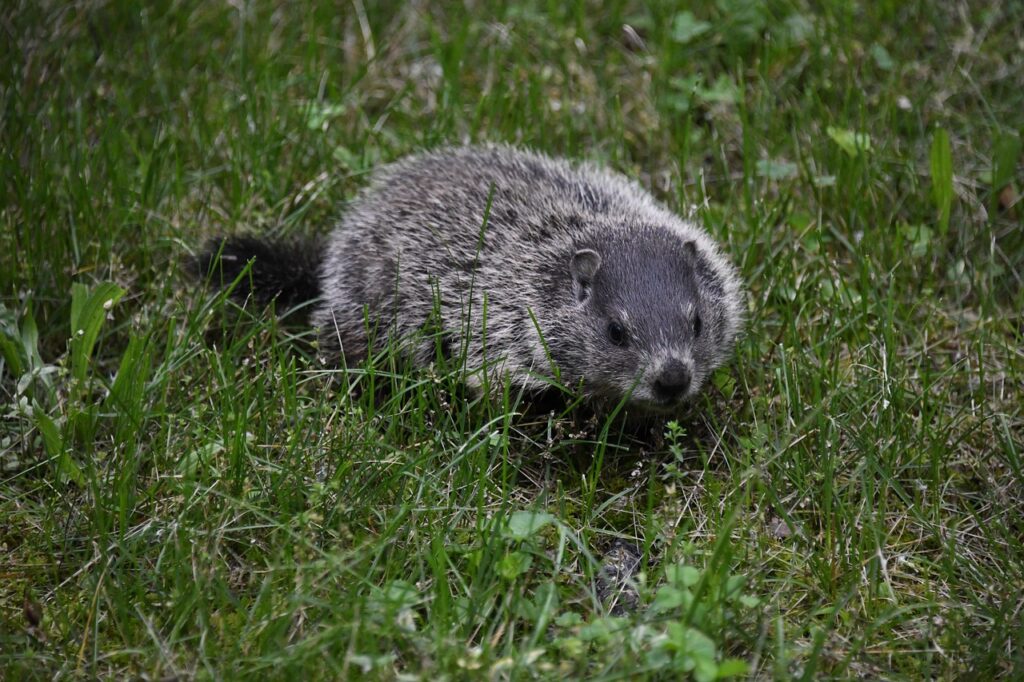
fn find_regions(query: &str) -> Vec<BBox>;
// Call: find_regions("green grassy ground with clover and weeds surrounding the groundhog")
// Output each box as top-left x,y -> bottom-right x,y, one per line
0,0 -> 1024,681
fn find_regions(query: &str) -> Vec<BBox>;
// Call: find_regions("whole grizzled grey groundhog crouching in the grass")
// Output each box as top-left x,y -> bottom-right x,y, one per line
197,145 -> 742,412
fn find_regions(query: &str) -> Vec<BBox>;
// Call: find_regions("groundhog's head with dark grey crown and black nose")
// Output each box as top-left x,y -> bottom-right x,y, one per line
568,225 -> 739,411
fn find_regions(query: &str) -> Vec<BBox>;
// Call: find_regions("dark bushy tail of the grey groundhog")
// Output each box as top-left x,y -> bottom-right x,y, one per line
193,232 -> 323,312
